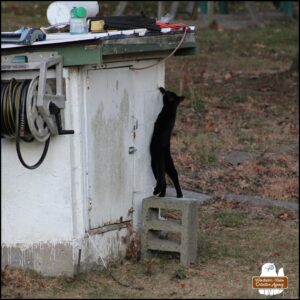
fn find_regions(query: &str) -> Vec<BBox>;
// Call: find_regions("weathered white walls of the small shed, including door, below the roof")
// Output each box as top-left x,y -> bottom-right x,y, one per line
1,60 -> 164,275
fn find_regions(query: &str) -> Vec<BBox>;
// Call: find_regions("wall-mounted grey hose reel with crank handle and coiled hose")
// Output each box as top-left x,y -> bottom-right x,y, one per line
1,54 -> 74,169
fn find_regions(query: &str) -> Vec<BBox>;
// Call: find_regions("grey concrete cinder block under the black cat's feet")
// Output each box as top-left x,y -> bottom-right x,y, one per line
141,196 -> 199,265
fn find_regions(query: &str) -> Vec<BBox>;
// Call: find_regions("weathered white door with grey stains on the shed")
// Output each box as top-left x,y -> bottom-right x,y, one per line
86,68 -> 135,229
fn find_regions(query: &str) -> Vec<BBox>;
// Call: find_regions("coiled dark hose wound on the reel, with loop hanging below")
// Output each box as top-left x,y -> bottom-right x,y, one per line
1,78 -> 50,169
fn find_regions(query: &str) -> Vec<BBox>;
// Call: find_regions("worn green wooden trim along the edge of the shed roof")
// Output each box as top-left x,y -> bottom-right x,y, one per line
2,33 -> 196,67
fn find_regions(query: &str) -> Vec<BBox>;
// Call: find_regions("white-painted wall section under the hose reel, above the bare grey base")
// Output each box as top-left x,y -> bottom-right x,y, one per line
1,127 -> 73,244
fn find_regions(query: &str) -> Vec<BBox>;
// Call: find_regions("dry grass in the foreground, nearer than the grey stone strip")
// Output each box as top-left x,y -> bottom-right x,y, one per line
1,200 -> 299,299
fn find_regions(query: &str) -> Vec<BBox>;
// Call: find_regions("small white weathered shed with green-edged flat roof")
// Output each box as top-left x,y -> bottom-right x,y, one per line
1,29 -> 196,275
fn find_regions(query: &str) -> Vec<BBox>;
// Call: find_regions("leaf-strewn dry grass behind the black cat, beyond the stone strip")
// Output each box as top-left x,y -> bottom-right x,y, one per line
166,24 -> 299,201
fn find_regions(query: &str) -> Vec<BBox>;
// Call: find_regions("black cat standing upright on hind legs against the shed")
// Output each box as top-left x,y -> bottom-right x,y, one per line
150,87 -> 184,198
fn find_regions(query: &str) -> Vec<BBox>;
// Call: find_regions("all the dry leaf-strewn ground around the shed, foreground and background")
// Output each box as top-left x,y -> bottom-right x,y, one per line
1,1 -> 299,299
